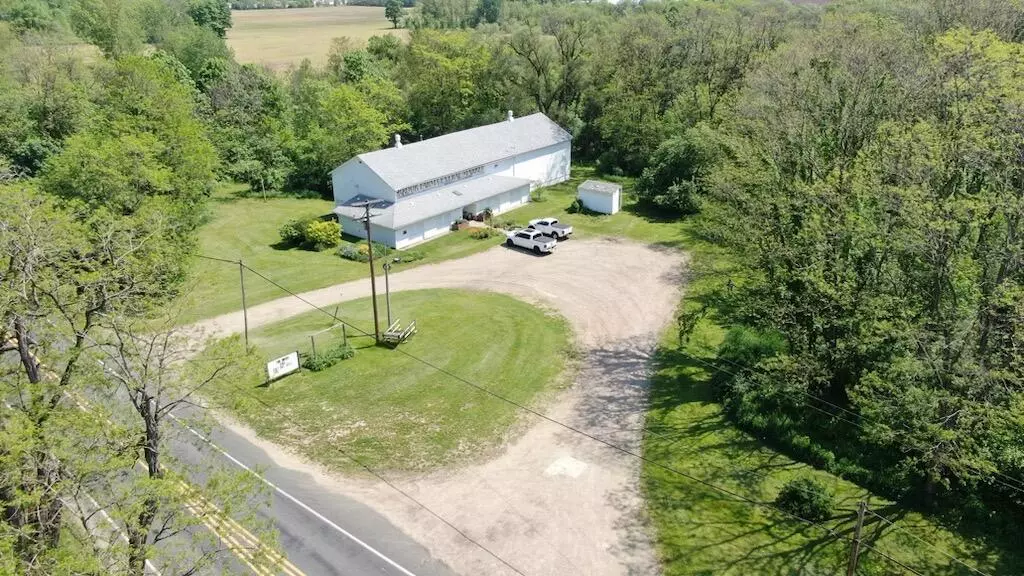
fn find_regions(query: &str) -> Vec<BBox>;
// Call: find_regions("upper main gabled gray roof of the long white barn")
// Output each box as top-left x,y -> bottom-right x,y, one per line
335,113 -> 572,191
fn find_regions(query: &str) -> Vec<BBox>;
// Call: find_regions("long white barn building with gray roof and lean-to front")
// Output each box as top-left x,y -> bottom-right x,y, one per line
331,112 -> 571,248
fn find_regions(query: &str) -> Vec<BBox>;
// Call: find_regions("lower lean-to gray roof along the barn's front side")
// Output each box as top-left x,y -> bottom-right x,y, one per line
334,174 -> 530,230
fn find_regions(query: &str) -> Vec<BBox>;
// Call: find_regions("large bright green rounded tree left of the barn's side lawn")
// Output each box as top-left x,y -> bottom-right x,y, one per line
41,56 -> 216,230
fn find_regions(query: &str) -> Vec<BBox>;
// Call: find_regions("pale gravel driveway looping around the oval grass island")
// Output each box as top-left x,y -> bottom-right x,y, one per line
194,240 -> 686,576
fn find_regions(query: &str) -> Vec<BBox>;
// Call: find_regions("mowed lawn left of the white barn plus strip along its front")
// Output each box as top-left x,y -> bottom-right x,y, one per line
178,186 -> 501,324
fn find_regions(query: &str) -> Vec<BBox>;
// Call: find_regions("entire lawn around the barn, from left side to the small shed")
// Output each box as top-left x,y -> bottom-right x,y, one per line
179,166 -> 679,324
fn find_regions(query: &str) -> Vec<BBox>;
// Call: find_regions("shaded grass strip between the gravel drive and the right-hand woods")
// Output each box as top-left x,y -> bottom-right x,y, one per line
643,243 -> 1024,576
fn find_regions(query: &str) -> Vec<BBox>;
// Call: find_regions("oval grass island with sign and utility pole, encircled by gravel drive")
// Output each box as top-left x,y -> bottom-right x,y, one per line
204,290 -> 571,471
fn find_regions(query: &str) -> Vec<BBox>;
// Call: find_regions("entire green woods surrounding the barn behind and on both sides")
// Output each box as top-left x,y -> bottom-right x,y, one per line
0,0 -> 1024,574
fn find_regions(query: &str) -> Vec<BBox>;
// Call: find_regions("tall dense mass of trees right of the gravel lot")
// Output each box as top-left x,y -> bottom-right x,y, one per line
702,16 -> 1024,516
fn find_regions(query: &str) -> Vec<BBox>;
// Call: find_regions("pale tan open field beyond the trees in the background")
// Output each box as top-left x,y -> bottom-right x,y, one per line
227,6 -> 409,70
